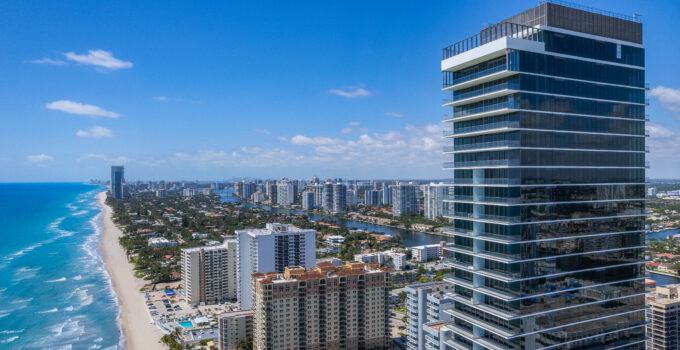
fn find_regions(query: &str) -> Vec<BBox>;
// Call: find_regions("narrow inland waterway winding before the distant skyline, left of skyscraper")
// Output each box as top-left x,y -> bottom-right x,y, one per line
216,189 -> 453,247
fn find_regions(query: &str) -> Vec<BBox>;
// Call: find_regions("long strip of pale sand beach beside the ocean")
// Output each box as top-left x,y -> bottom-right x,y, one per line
97,192 -> 165,350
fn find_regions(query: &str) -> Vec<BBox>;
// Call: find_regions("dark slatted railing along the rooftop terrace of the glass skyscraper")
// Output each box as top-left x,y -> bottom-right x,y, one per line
442,22 -> 543,60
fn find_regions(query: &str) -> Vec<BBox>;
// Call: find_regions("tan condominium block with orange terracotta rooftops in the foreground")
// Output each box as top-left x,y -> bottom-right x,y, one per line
253,261 -> 391,350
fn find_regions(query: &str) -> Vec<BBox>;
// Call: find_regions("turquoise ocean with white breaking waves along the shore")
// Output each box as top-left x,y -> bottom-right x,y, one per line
0,183 -> 123,349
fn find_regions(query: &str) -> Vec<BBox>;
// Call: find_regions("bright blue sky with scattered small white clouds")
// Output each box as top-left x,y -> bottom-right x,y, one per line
0,0 -> 680,182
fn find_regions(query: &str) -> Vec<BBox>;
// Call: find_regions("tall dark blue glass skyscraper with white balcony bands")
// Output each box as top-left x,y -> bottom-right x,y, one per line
441,1 -> 647,349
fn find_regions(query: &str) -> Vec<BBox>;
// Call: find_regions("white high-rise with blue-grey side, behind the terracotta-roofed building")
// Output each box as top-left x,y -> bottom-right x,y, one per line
236,223 -> 316,310
